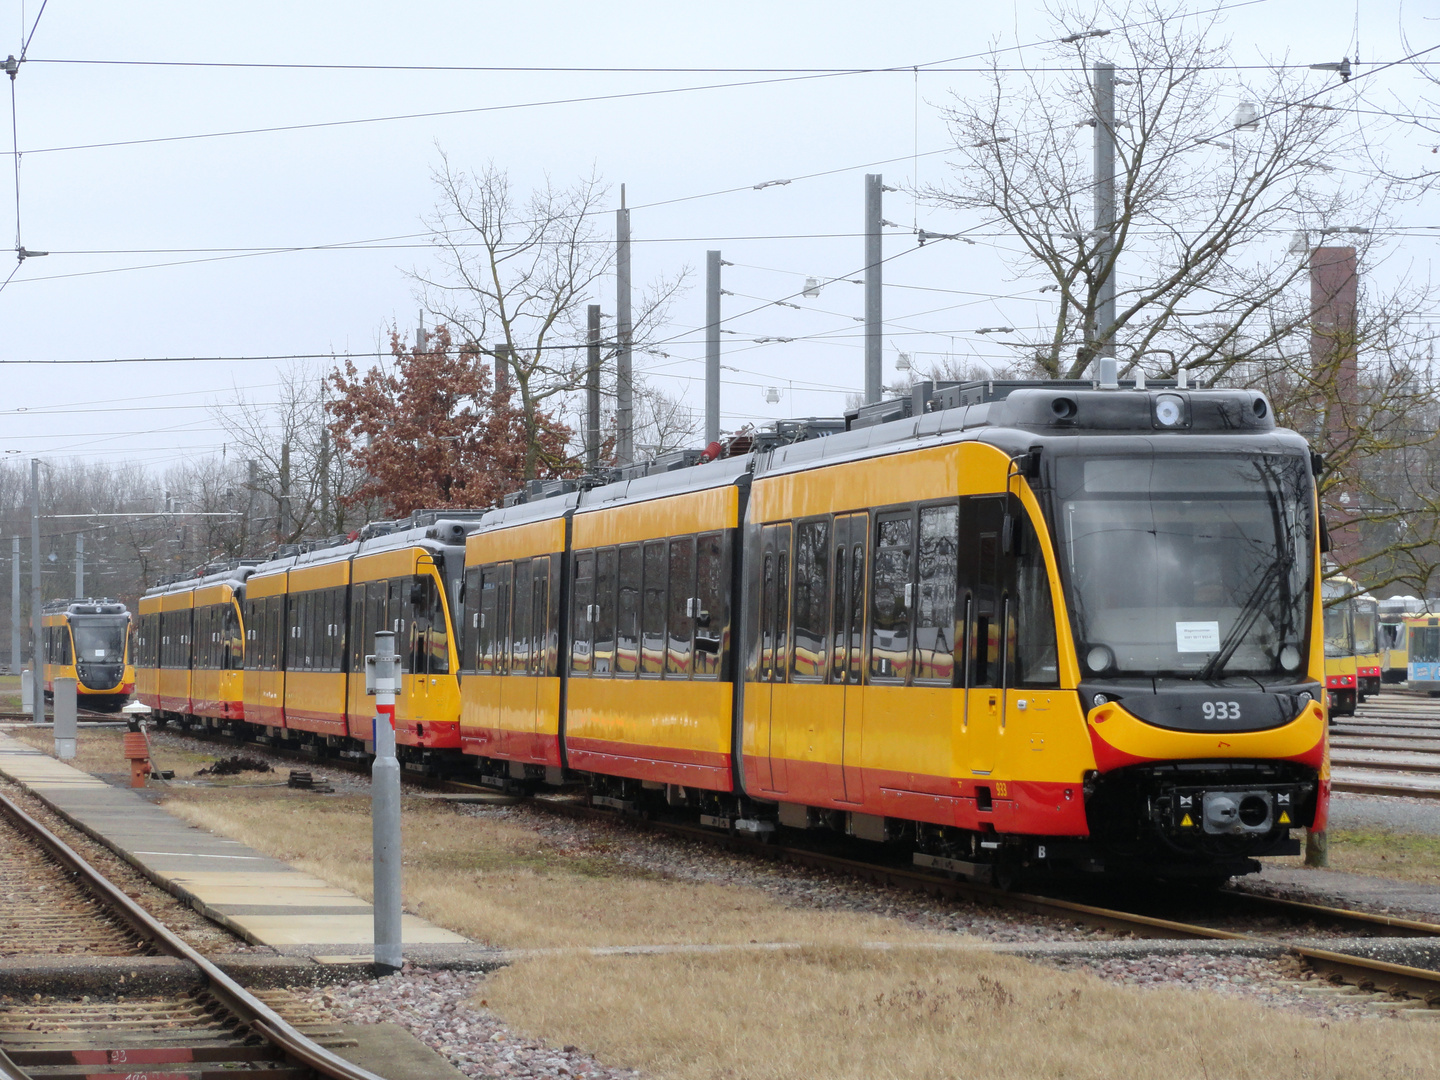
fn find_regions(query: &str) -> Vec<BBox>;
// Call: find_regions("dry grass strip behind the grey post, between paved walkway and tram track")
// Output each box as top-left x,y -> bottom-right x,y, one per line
166,789 -> 953,948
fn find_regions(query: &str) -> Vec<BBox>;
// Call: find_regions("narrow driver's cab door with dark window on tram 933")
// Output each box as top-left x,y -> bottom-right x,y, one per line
960,498 -> 1007,776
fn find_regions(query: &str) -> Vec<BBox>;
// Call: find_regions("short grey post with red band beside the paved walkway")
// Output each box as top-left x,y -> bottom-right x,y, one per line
370,631 -> 405,975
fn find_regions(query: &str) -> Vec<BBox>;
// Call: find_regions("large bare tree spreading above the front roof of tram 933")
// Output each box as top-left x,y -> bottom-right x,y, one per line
929,0 -> 1384,382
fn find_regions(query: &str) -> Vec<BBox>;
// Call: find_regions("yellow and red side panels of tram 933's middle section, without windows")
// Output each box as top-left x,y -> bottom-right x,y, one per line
564,484 -> 740,791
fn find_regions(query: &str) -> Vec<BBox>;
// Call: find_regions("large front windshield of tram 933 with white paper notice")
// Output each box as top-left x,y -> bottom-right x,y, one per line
1054,454 -> 1313,680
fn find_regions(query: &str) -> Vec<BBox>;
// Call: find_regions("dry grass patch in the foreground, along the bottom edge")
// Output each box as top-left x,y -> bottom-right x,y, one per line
484,948 -> 1440,1080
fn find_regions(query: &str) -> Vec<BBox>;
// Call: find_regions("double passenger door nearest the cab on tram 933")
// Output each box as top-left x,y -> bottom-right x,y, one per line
831,513 -> 870,802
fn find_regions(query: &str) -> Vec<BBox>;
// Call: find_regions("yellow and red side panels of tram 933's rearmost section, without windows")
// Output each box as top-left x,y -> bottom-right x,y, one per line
456,517 -> 566,766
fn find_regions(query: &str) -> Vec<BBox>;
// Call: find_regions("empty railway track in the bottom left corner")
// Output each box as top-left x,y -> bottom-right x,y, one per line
0,793 -> 380,1080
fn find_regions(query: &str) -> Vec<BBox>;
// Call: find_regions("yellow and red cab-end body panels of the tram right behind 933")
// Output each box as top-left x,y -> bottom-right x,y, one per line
348,547 -> 459,749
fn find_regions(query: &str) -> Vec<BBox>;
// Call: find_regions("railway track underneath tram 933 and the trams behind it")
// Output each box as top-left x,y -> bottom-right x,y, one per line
53,714 -> 1440,1008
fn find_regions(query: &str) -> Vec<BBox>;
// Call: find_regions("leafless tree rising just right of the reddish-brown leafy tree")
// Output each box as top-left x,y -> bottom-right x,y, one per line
413,153 -> 684,478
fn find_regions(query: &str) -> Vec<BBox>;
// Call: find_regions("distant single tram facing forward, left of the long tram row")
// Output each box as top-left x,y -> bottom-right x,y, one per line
40,599 -> 135,710
